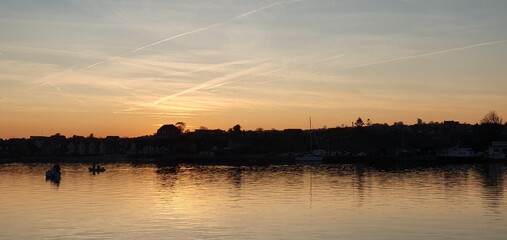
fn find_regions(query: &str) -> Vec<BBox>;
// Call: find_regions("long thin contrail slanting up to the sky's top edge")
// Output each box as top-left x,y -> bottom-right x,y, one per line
80,0 -> 300,70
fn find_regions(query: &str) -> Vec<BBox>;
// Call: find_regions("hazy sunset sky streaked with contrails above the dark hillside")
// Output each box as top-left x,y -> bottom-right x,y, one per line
0,0 -> 507,139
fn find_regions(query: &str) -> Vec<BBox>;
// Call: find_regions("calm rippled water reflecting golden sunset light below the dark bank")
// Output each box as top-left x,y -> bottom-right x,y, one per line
0,164 -> 507,240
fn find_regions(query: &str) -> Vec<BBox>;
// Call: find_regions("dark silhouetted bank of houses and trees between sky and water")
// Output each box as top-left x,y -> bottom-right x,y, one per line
0,112 -> 507,163
